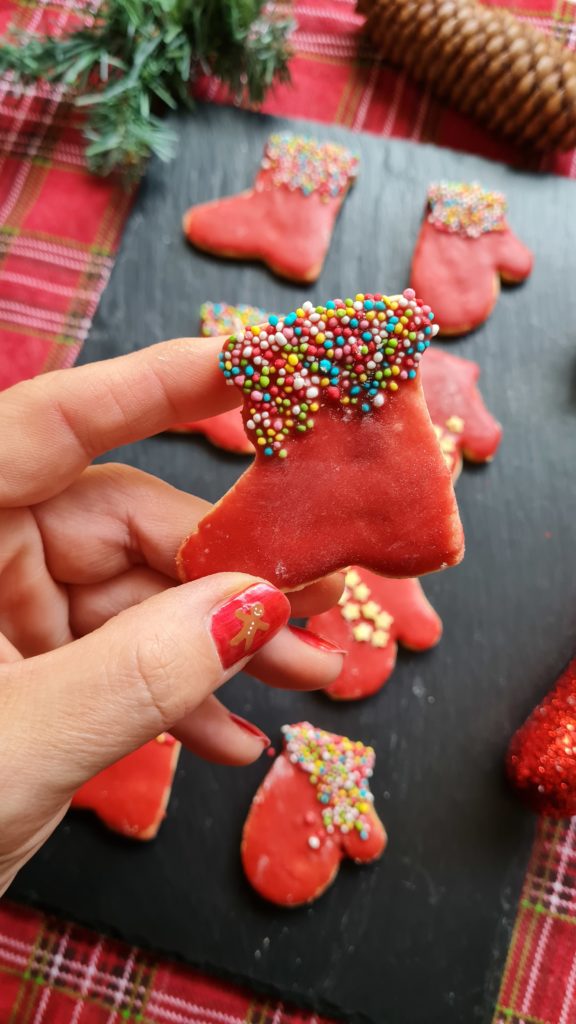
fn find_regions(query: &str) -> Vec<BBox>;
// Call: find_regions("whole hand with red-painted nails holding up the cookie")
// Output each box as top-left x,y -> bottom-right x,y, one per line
0,339 -> 341,893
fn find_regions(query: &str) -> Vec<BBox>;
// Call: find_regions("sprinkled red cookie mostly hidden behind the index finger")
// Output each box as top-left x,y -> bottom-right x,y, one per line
168,302 -> 268,455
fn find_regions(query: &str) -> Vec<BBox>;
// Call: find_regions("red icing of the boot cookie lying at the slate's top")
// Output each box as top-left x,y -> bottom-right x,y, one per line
183,170 -> 352,282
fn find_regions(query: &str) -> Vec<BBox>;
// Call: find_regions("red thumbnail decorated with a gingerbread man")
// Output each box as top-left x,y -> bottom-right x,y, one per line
210,583 -> 290,669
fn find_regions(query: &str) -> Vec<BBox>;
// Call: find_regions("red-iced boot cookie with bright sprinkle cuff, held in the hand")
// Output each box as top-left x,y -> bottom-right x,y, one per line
178,290 -> 463,590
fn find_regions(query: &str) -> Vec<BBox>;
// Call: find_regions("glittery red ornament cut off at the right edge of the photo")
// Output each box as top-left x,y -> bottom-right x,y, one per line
506,658 -> 576,818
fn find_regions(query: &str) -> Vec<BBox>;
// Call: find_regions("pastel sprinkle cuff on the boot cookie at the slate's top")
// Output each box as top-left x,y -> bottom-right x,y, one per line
261,132 -> 359,201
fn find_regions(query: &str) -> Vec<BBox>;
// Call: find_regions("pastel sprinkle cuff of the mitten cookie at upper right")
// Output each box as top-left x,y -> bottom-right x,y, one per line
427,181 -> 506,239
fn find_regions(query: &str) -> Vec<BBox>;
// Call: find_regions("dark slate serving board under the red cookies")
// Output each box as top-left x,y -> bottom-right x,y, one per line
7,109 -> 576,1024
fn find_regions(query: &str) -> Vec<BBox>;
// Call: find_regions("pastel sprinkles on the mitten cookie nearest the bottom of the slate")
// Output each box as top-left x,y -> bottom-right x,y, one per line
282,722 -> 375,840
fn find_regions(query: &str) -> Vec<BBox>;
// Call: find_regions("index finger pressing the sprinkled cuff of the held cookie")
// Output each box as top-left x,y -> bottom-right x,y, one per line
0,338 -> 239,508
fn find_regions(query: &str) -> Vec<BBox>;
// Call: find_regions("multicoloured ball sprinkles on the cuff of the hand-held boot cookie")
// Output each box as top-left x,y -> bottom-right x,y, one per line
220,288 -> 439,459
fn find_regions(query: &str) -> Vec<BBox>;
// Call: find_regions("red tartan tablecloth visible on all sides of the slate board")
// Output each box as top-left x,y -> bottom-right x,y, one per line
0,0 -> 576,1024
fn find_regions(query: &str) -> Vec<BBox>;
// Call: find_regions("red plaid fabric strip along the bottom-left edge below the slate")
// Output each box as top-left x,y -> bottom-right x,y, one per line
0,903 -> 329,1024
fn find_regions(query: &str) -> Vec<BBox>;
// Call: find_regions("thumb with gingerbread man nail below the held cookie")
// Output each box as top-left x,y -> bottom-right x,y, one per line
5,572 -> 290,801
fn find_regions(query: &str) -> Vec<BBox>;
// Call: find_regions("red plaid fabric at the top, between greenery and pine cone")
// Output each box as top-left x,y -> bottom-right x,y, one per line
193,0 -> 576,178
